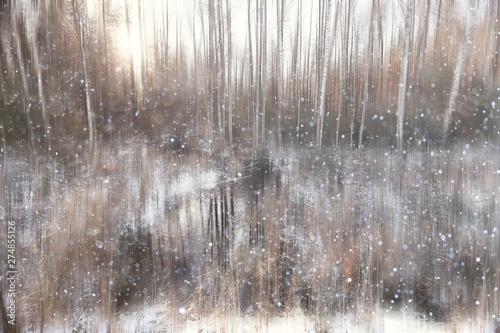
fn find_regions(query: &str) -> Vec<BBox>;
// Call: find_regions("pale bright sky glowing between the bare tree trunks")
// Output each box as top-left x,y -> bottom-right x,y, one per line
88,0 -> 476,76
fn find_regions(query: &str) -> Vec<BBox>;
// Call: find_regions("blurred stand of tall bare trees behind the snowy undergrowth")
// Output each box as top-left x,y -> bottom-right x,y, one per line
0,0 -> 500,156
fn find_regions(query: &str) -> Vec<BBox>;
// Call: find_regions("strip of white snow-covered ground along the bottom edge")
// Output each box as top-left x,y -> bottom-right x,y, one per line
115,305 -> 493,333
